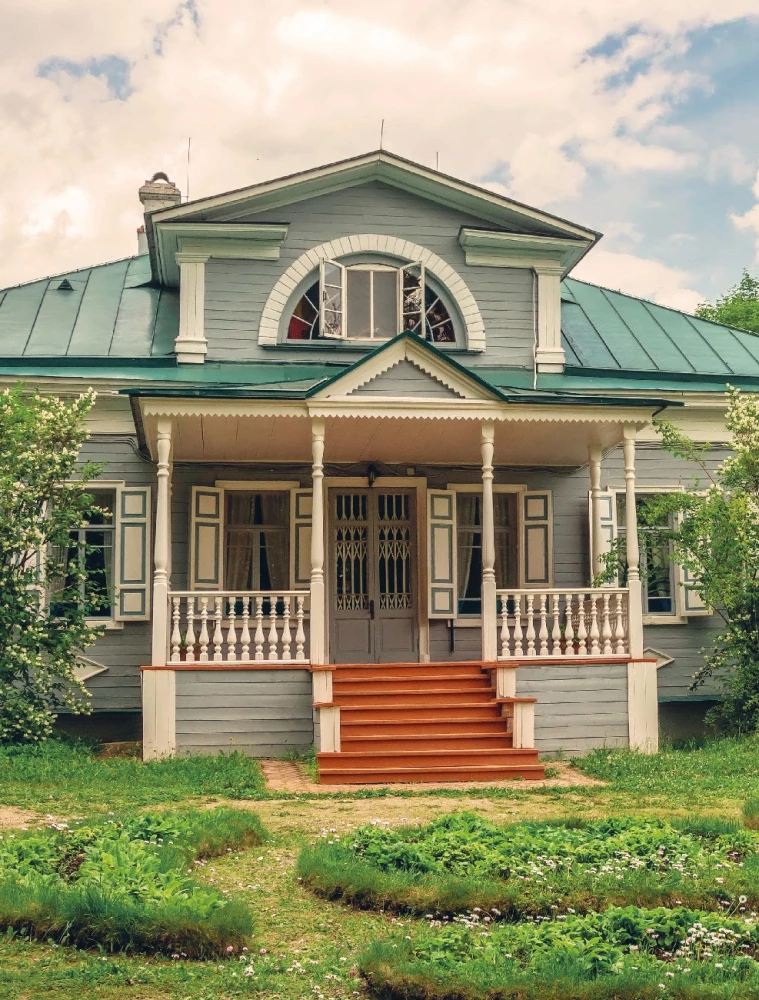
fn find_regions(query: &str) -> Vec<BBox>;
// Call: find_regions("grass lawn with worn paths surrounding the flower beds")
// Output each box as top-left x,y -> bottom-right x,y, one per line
0,740 -> 759,1000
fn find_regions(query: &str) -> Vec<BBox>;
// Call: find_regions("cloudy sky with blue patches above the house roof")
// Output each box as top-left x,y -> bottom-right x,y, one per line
0,0 -> 759,310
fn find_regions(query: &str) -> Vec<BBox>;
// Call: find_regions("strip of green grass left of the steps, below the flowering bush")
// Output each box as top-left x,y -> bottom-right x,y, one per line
0,739 -> 266,812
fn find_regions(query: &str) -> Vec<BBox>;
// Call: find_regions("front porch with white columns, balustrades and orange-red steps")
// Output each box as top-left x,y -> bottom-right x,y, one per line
134,386 -> 656,781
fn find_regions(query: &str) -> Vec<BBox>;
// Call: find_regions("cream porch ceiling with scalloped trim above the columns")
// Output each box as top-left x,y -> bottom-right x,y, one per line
142,399 -> 651,466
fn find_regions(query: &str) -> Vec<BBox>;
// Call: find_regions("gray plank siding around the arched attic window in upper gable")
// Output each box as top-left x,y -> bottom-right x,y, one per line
205,182 -> 533,366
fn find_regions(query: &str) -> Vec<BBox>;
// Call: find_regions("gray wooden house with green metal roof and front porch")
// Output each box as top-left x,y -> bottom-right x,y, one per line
0,151 -> 748,782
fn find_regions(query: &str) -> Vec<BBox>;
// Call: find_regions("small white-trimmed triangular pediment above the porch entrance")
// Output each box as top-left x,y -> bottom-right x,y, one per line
314,334 -> 500,405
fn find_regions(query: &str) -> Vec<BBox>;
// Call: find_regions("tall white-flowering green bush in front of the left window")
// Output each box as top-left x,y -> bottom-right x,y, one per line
0,386 -> 101,743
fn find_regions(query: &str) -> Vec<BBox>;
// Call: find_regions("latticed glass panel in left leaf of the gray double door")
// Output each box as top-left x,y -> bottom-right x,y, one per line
333,493 -> 369,611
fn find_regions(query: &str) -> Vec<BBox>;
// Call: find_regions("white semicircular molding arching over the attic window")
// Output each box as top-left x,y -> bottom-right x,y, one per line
258,233 -> 485,351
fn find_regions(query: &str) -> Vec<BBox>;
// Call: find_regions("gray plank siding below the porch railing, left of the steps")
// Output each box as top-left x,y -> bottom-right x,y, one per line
176,670 -> 314,757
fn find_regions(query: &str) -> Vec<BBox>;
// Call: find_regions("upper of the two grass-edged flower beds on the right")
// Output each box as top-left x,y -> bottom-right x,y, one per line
299,813 -> 759,920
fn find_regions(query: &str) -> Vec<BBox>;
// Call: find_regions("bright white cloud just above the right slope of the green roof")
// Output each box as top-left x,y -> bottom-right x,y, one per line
572,247 -> 704,312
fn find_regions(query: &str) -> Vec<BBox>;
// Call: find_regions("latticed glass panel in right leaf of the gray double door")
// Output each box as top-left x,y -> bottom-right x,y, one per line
377,493 -> 411,611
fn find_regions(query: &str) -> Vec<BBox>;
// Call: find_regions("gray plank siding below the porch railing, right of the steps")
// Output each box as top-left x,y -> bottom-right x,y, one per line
517,663 -> 629,754
